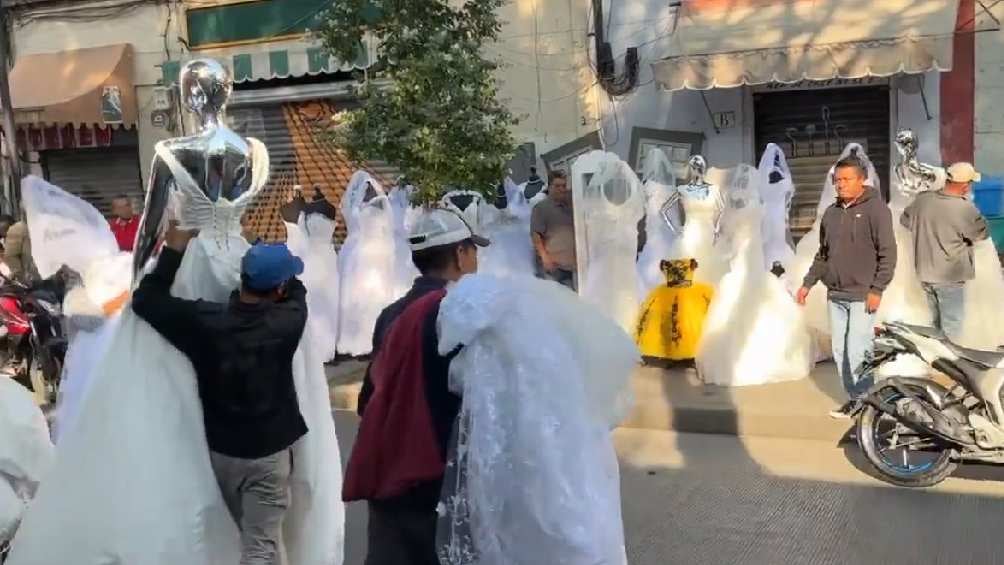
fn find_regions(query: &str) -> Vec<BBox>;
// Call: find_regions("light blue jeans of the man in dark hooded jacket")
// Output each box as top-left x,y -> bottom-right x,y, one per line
828,299 -> 875,399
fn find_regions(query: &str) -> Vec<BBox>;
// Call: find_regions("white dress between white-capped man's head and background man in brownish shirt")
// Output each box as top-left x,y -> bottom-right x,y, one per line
478,178 -> 545,277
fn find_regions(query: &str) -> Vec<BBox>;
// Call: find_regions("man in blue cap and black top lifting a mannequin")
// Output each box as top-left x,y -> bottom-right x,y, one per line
133,225 -> 307,565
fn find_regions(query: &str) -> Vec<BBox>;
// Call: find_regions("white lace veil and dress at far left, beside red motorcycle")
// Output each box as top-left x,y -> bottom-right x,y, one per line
21,177 -> 133,440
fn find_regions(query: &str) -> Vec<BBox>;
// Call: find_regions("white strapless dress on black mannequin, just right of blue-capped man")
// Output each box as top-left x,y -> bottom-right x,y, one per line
286,213 -> 339,362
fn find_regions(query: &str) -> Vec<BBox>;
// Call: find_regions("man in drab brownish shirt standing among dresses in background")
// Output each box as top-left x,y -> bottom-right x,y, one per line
530,171 -> 578,290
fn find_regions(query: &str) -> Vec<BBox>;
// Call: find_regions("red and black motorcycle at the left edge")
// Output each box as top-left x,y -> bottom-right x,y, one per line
0,277 -> 66,403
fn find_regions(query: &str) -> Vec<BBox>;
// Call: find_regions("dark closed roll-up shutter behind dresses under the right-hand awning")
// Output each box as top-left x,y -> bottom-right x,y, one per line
753,86 -> 890,239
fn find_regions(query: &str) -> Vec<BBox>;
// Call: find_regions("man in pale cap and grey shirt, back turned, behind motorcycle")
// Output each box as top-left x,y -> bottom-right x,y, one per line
900,163 -> 990,338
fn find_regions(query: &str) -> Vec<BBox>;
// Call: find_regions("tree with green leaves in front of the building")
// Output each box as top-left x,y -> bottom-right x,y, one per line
319,0 -> 516,203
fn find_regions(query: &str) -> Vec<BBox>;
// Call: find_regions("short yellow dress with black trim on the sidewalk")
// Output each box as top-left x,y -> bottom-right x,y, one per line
635,259 -> 714,361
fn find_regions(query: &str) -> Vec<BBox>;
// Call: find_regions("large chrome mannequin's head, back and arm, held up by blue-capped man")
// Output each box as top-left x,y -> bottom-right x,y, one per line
134,59 -> 252,276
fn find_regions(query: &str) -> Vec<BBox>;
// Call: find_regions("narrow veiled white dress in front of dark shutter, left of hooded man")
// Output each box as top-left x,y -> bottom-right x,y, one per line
757,144 -> 795,271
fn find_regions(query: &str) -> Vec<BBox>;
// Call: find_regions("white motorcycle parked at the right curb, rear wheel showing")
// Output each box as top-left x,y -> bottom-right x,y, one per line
853,322 -> 1004,487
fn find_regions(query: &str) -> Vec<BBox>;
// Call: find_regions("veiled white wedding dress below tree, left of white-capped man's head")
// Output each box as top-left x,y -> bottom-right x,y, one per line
338,171 -> 415,356
